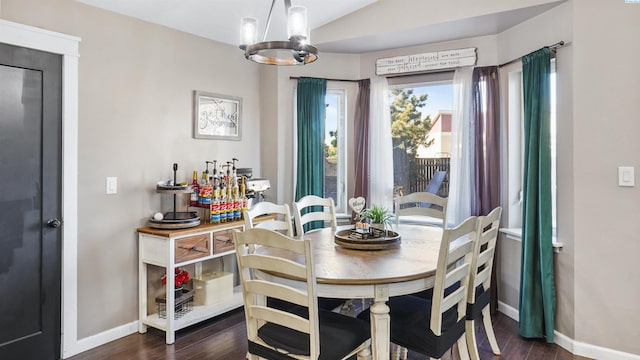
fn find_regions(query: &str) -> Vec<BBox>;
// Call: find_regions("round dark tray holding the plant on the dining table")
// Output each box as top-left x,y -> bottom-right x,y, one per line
334,229 -> 400,250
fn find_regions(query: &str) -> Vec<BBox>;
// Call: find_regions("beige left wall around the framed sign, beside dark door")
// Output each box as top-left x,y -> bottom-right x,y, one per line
0,0 -> 261,339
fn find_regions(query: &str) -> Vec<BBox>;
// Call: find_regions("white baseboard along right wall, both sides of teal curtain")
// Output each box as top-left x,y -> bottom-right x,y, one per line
498,301 -> 640,360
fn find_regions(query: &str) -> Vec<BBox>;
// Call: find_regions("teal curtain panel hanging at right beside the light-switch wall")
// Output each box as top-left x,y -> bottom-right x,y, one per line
519,48 -> 556,343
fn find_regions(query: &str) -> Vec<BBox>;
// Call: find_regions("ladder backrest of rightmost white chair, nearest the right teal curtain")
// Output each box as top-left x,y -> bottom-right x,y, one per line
467,206 -> 502,304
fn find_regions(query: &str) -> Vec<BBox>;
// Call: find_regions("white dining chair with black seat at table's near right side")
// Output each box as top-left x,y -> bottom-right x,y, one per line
358,216 -> 478,360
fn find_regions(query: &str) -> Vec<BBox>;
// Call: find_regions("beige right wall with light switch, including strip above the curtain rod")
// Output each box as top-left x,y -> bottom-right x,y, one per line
498,0 -> 640,359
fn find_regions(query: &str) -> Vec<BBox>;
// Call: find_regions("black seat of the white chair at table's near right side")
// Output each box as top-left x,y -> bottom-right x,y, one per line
358,295 -> 465,358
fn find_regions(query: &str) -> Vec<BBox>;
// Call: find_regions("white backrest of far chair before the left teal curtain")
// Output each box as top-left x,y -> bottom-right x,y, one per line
293,195 -> 338,237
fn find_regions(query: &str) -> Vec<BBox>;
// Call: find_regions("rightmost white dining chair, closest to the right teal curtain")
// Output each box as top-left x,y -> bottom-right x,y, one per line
466,206 -> 502,360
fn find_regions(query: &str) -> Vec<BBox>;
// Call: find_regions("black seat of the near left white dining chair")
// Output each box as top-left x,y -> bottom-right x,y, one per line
256,308 -> 371,360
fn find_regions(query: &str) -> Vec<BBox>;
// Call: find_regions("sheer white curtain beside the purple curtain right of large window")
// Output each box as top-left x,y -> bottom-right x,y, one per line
447,68 -> 475,227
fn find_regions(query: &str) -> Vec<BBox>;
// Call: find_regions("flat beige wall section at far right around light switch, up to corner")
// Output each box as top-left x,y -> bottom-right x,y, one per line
569,0 -> 640,355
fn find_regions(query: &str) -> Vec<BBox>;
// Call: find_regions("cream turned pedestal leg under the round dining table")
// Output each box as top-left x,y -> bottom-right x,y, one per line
370,286 -> 391,360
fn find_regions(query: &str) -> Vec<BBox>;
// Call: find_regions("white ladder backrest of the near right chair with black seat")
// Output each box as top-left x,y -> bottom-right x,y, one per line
430,216 -> 478,336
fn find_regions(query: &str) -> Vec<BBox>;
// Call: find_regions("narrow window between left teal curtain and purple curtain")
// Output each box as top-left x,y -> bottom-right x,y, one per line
324,89 -> 347,213
